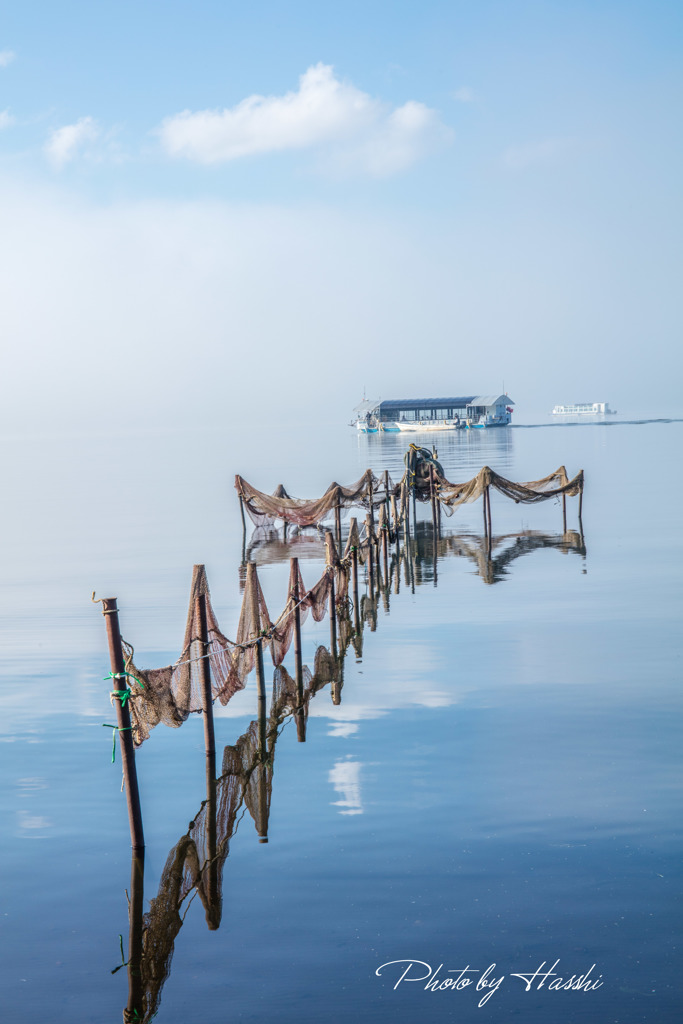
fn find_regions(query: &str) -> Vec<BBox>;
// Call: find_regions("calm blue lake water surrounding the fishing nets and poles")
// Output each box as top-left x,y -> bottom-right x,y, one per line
0,422 -> 683,1024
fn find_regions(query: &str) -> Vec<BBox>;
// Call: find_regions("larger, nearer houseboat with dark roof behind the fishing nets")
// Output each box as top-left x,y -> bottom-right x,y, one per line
351,394 -> 514,434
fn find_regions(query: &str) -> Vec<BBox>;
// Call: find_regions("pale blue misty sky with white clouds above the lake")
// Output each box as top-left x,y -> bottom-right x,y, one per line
0,0 -> 683,429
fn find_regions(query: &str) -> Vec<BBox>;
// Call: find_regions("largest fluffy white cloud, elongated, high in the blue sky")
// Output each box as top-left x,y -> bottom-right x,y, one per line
159,63 -> 450,176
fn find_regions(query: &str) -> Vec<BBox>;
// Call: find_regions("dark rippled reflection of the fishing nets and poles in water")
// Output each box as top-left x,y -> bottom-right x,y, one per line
120,512 -> 586,1020
